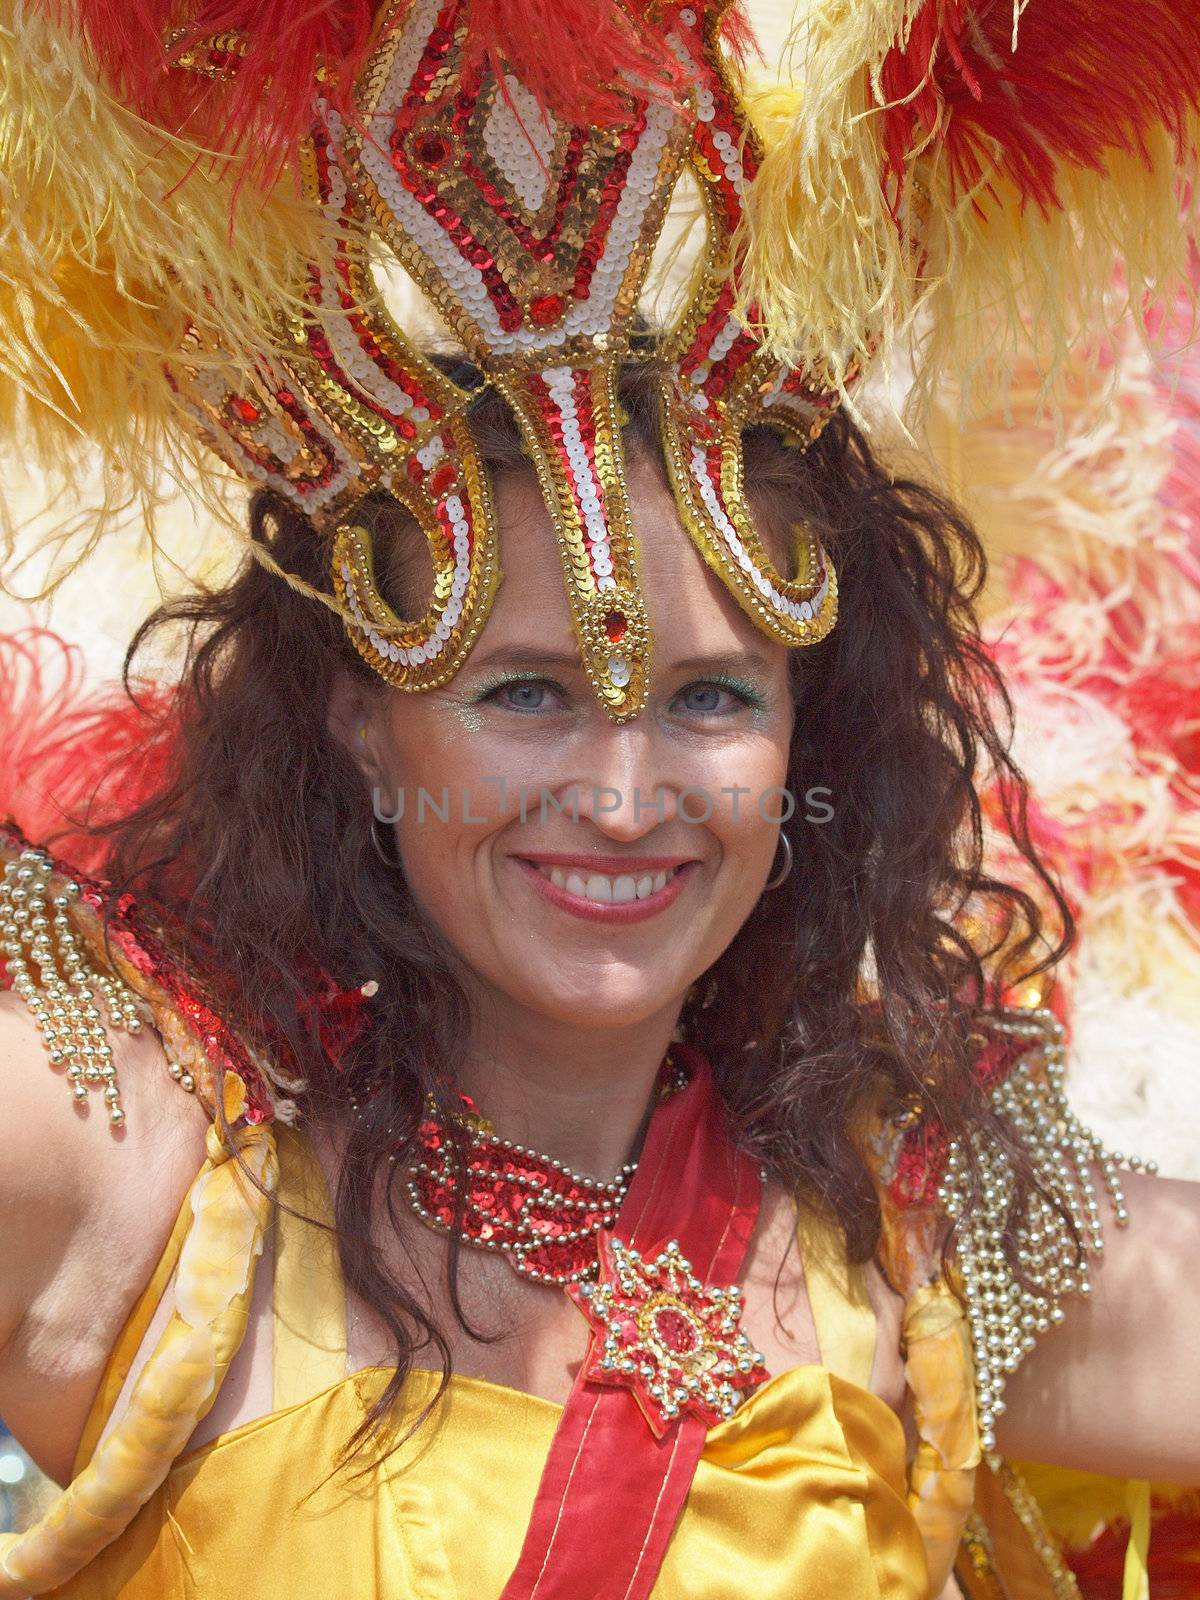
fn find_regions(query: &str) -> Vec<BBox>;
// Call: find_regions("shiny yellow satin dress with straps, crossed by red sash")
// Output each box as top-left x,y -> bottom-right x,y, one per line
53,1128 -> 928,1600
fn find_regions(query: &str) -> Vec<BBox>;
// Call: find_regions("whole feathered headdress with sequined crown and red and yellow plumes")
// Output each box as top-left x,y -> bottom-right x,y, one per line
0,0 -> 1200,720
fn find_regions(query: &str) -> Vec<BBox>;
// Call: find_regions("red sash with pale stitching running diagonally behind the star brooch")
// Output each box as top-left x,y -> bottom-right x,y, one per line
501,1045 -> 762,1600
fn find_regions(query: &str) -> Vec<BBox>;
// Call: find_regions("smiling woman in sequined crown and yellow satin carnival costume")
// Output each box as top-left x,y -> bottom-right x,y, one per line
0,6 -> 1200,1597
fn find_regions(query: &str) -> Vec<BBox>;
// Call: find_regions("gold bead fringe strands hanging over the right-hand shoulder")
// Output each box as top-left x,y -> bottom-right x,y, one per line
938,1010 -> 1157,1467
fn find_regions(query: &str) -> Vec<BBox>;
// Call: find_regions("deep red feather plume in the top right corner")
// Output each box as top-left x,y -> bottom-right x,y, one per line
882,0 -> 1200,213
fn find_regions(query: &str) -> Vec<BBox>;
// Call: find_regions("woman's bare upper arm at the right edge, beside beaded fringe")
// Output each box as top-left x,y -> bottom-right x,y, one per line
997,1174 -> 1200,1485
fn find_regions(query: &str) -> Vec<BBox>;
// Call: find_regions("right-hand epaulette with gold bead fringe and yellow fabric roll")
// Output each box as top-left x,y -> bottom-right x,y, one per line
867,1008 -> 1155,1600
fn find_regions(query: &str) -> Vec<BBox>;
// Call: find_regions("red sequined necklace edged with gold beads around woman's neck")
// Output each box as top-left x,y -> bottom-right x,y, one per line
405,1054 -> 688,1283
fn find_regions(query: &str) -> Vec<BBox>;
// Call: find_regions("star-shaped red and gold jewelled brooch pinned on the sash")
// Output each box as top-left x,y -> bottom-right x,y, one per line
566,1229 -> 766,1438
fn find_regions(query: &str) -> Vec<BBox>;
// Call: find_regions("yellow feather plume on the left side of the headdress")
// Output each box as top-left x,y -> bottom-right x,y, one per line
0,0 -> 366,604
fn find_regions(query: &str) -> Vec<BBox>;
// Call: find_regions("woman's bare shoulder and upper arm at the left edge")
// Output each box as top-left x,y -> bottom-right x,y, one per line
0,992 -> 208,1478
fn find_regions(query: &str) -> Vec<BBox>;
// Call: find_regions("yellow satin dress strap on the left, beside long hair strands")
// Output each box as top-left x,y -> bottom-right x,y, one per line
272,1125 -> 347,1411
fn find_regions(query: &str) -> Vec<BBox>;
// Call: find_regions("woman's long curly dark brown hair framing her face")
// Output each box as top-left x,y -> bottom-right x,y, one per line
80,363 -> 1070,1451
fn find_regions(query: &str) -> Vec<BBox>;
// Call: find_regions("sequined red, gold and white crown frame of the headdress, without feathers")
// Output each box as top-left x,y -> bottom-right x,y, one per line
171,0 -> 838,722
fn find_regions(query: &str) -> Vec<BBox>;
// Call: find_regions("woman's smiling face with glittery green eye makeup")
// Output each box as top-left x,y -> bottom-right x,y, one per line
350,456 -> 792,1027
